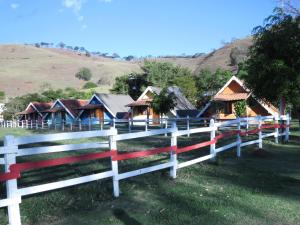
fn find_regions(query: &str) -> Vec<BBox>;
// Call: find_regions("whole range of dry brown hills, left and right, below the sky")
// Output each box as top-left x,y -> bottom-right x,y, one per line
0,38 -> 252,97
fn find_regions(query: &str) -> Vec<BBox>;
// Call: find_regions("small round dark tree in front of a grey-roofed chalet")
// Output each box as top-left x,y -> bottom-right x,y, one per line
151,88 -> 176,117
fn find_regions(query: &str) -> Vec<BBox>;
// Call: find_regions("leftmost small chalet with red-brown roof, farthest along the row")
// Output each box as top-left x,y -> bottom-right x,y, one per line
16,102 -> 52,121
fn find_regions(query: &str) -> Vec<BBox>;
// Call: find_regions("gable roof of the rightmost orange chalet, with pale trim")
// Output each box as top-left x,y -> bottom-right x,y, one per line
198,76 -> 278,117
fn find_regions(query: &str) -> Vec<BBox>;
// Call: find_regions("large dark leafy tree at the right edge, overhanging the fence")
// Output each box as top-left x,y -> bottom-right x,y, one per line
244,9 -> 300,123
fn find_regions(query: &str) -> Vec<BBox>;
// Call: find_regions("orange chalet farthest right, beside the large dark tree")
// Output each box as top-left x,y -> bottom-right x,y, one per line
198,76 -> 278,120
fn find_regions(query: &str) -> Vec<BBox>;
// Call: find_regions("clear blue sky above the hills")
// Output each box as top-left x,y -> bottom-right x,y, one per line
0,0 -> 278,56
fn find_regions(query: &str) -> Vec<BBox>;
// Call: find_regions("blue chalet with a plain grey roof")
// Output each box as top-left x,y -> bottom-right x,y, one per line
78,93 -> 133,124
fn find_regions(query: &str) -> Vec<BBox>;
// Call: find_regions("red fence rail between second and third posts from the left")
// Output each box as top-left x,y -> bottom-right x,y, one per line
112,146 -> 177,161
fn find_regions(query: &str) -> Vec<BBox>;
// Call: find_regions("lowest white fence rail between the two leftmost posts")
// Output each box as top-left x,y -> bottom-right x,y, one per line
19,170 -> 113,196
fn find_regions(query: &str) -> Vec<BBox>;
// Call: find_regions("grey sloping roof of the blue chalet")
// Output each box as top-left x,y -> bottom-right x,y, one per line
95,93 -> 133,117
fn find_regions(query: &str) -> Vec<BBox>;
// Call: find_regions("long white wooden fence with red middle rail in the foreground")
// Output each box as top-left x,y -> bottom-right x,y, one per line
0,115 -> 290,225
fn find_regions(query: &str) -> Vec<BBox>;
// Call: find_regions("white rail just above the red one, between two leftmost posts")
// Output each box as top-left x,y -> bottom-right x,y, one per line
17,142 -> 109,156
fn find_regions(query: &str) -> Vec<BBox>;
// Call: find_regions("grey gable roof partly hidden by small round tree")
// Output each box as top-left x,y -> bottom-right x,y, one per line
137,86 -> 196,115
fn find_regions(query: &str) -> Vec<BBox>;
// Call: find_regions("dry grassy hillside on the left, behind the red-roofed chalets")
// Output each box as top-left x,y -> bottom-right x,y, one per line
0,45 -> 140,96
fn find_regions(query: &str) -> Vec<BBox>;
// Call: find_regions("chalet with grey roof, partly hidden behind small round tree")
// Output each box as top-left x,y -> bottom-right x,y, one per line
127,86 -> 199,124
